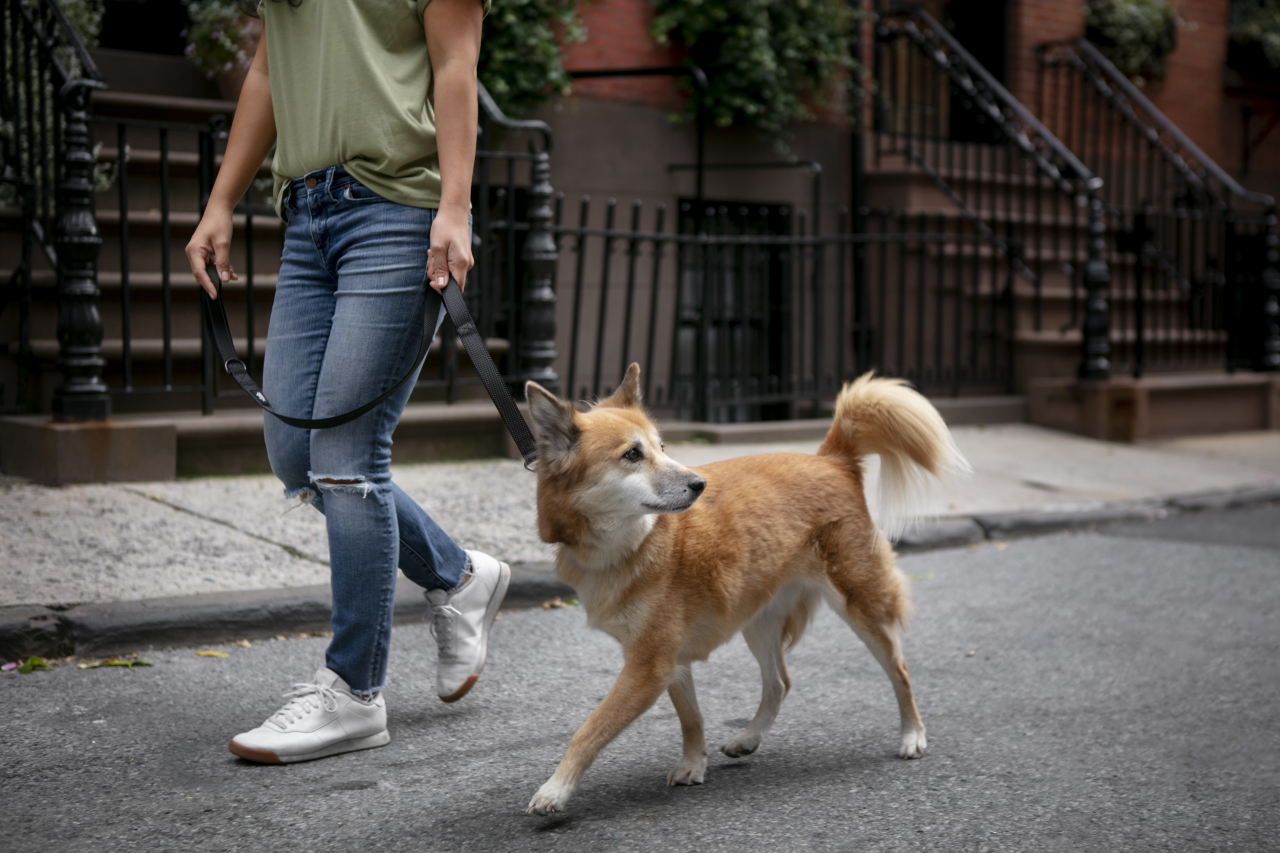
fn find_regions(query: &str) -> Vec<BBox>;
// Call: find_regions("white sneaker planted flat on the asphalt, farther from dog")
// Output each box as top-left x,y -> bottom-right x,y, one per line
230,669 -> 392,765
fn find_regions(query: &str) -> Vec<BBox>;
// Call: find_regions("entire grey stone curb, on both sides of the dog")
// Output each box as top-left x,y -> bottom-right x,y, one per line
0,483 -> 1280,661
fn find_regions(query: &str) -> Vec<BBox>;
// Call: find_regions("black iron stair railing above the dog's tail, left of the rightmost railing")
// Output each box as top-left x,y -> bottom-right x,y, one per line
872,4 -> 1111,379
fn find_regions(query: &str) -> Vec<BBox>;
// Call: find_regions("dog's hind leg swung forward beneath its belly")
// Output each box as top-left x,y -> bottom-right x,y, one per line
721,592 -> 809,758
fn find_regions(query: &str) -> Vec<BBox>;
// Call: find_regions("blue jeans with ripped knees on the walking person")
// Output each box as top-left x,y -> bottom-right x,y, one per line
262,167 -> 467,693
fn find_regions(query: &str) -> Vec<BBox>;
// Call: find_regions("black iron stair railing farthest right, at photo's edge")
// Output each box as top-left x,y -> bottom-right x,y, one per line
1038,38 -> 1280,377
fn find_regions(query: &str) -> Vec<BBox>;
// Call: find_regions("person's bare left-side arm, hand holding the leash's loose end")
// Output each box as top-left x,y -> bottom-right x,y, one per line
187,26 -> 275,298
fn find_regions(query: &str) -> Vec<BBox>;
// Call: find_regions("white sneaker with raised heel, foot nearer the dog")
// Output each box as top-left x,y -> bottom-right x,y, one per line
426,551 -> 511,702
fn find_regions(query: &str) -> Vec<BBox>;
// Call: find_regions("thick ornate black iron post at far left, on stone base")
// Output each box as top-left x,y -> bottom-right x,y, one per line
52,79 -> 111,421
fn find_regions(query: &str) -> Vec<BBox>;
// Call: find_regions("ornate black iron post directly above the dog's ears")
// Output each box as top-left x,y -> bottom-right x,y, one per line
508,151 -> 559,393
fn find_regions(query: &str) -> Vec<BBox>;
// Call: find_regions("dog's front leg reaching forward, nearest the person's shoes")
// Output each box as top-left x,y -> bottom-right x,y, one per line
525,658 -> 675,815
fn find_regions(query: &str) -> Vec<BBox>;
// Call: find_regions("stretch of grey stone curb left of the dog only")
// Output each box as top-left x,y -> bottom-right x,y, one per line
0,564 -> 575,661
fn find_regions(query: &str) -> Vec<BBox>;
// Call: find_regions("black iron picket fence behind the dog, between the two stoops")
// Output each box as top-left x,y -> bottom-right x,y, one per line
554,192 -> 1012,421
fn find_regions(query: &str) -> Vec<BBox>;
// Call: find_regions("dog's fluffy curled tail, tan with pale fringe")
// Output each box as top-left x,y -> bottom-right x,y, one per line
818,373 -> 973,539
